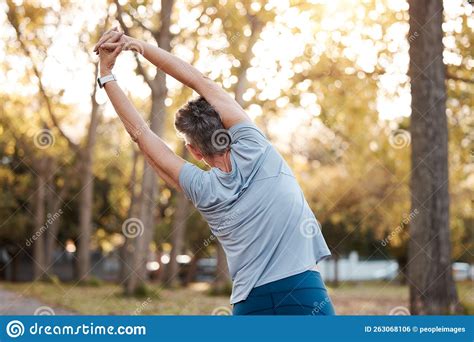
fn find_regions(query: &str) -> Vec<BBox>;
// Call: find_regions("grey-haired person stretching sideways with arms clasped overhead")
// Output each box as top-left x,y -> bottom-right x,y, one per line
94,29 -> 334,315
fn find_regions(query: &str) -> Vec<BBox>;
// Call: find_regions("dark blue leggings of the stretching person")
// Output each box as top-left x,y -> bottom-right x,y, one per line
233,271 -> 335,315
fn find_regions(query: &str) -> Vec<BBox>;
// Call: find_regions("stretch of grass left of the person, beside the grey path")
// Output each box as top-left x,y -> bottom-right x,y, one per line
0,282 -> 230,315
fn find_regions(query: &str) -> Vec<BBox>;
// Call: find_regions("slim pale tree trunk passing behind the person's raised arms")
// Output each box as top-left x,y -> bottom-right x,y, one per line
125,0 -> 174,295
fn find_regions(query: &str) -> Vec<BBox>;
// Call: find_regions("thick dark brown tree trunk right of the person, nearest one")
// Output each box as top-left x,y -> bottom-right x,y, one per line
408,0 -> 459,315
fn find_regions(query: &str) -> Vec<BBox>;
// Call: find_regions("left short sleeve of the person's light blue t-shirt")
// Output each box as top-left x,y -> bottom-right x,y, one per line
179,162 -> 209,208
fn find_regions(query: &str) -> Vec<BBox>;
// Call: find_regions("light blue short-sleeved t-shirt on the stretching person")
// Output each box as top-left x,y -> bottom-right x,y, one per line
179,122 -> 331,304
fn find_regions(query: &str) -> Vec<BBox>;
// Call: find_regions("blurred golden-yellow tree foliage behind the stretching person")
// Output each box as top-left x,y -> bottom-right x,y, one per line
0,0 -> 474,284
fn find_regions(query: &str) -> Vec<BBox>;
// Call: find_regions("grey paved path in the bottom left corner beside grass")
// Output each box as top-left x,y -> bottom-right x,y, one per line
0,288 -> 74,315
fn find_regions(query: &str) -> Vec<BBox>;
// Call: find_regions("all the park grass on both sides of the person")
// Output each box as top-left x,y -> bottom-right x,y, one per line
0,282 -> 474,315
